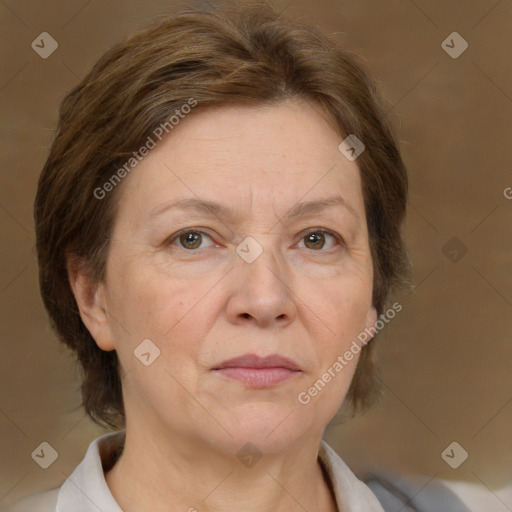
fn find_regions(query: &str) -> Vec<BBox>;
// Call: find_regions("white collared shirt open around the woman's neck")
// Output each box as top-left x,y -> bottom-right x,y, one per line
5,431 -> 384,512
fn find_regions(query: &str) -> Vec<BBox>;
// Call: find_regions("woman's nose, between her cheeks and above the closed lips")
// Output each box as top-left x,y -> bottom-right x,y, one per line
227,243 -> 297,328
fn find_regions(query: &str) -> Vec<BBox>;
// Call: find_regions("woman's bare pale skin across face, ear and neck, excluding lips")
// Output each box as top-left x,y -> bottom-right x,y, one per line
70,100 -> 376,512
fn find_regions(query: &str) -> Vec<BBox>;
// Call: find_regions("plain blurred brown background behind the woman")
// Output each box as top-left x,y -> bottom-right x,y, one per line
0,0 -> 512,512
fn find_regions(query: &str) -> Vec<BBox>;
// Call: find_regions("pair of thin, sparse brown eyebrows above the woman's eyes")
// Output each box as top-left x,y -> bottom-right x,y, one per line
149,196 -> 359,222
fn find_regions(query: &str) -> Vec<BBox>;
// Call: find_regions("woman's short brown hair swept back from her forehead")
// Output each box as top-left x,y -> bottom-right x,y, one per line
34,2 -> 408,429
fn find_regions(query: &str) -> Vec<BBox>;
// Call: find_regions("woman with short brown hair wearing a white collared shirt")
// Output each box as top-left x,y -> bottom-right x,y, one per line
14,3 -> 407,512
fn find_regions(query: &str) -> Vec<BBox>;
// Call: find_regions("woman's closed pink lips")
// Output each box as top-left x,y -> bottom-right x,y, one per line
212,354 -> 302,389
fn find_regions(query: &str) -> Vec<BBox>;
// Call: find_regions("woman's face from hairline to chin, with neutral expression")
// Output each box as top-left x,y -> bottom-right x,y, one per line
92,101 -> 376,453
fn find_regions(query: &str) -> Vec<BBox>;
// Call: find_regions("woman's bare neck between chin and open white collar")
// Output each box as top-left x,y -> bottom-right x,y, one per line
106,428 -> 338,512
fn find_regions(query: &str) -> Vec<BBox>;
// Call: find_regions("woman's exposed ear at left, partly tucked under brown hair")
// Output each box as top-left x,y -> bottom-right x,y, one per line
67,257 -> 115,351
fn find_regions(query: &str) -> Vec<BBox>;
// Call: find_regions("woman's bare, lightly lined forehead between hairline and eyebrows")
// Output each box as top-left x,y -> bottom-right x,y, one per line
114,100 -> 364,225
